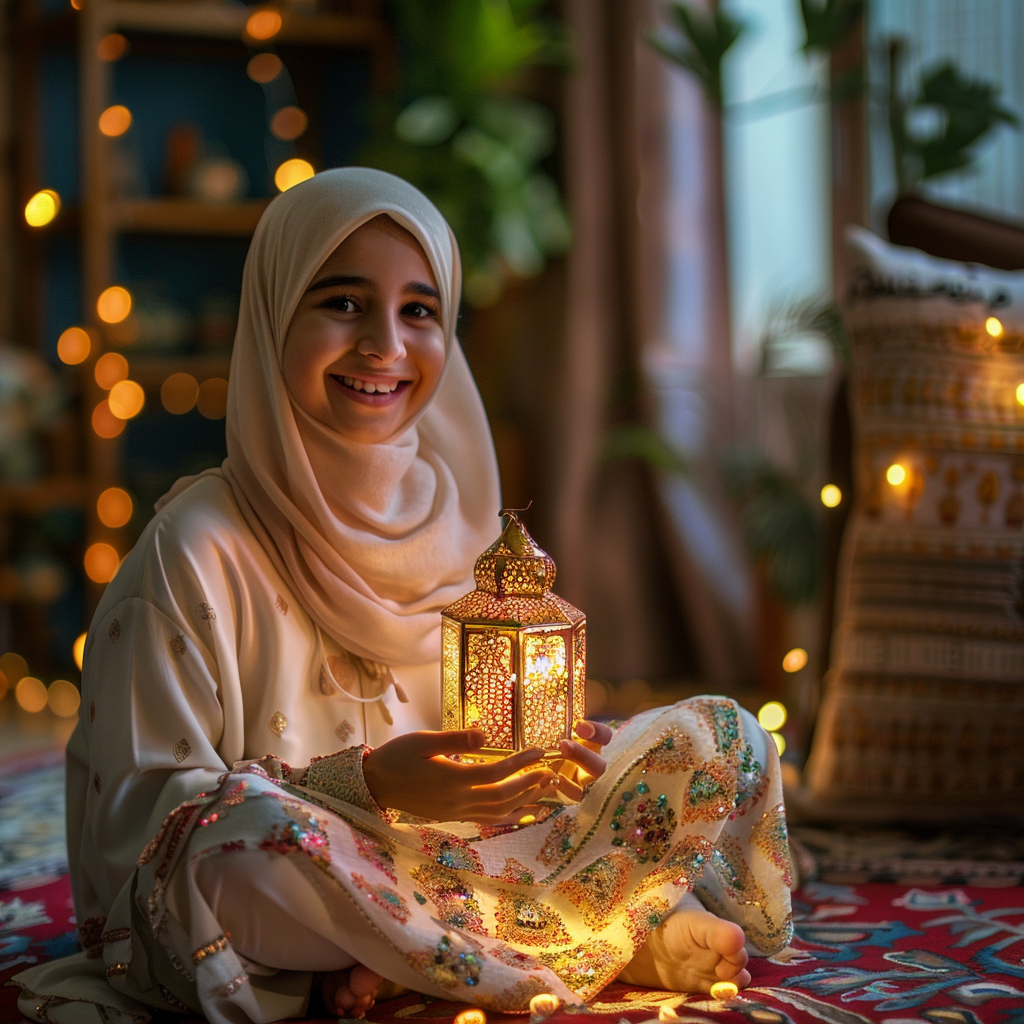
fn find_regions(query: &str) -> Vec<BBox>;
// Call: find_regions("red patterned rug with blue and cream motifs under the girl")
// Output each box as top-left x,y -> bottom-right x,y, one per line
0,755 -> 1024,1024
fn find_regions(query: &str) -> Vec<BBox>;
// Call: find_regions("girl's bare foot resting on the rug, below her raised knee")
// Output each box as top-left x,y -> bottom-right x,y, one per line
618,894 -> 751,992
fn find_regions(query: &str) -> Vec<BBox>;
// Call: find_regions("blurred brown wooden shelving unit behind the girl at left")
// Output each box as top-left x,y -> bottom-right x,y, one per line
7,0 -> 393,655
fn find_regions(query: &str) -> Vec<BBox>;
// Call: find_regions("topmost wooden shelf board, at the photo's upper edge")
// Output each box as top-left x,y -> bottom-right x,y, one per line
102,0 -> 381,46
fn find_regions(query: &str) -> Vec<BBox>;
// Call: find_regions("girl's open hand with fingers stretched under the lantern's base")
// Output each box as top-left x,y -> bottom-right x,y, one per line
362,729 -> 561,824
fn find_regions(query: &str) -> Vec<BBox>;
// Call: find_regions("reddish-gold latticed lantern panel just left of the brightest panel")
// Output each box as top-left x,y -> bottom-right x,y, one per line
463,630 -> 515,750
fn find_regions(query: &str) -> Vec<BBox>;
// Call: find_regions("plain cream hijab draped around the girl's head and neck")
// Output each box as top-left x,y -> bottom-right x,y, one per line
168,168 -> 500,682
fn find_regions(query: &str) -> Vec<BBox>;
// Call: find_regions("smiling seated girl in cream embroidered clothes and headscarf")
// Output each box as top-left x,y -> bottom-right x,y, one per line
17,169 -> 791,1024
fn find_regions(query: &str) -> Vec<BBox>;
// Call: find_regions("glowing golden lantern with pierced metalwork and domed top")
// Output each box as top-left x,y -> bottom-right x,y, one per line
441,510 -> 587,761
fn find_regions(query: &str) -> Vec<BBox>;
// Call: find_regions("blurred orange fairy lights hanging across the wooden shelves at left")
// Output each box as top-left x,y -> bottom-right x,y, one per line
0,0 -> 315,718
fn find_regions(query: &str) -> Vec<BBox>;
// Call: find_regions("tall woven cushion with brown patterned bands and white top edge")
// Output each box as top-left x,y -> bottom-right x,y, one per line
805,228 -> 1024,820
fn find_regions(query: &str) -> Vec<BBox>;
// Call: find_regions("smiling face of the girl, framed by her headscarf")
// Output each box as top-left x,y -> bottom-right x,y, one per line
284,220 -> 444,444
